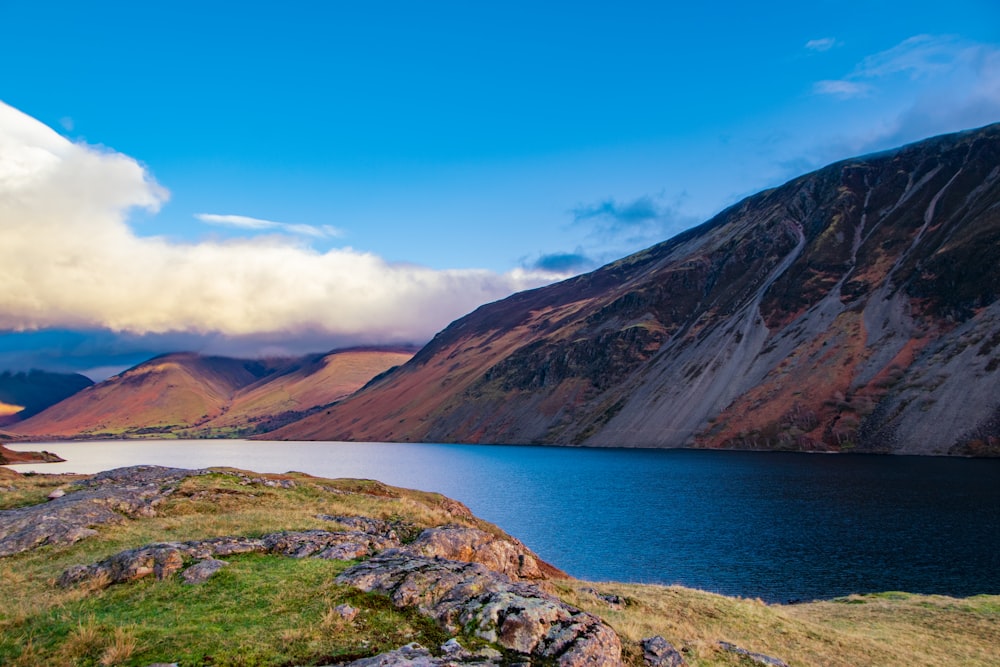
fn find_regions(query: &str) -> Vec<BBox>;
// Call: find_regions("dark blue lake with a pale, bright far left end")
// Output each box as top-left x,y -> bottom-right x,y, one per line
11,440 -> 1000,602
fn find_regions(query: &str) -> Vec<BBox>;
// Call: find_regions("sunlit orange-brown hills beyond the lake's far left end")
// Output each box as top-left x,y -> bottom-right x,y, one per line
10,349 -> 412,439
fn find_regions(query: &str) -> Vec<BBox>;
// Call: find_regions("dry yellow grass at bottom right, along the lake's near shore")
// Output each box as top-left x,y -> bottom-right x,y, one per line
556,581 -> 1000,667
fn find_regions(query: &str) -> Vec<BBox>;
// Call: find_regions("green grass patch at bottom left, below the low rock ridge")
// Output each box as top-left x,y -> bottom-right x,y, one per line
0,555 -> 448,666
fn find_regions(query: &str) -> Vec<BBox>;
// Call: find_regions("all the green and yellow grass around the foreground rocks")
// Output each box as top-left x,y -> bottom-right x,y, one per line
0,470 -> 1000,667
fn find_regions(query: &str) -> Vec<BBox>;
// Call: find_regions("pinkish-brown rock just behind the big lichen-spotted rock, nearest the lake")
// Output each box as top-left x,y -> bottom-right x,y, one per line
407,524 -> 555,580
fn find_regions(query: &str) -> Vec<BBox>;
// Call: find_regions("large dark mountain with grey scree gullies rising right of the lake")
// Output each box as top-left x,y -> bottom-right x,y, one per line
270,124 -> 1000,455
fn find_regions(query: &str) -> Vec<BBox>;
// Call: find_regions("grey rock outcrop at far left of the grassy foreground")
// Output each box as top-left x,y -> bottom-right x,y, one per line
0,466 -> 207,557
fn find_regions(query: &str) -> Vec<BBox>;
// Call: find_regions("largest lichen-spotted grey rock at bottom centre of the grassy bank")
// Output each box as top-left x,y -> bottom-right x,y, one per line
337,550 -> 621,667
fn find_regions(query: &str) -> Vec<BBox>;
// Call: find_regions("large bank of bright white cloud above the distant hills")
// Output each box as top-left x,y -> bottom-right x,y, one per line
0,102 -> 558,350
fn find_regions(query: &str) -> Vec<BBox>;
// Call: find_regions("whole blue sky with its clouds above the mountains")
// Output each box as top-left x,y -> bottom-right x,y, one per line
0,0 -> 1000,375
